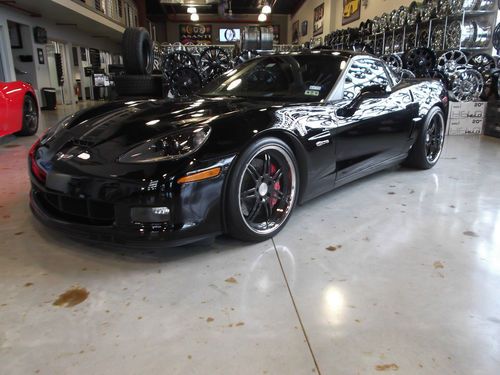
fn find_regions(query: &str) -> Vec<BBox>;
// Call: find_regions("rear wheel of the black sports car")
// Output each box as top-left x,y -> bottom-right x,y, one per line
404,107 -> 446,169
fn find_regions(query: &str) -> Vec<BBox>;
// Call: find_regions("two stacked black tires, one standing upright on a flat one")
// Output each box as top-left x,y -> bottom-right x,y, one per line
115,27 -> 163,97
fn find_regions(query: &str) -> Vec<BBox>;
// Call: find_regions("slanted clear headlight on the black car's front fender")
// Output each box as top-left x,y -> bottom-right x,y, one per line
118,127 -> 210,163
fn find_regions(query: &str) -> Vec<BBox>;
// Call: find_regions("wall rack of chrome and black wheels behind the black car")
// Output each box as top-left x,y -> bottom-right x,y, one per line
325,0 -> 500,101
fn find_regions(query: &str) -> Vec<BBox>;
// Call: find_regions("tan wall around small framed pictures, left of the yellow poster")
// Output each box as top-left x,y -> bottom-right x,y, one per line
288,0 -> 335,44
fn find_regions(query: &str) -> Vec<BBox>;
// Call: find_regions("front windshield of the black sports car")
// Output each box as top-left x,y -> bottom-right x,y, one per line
198,55 -> 346,102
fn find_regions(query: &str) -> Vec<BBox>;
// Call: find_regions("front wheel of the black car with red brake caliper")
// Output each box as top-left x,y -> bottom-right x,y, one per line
226,138 -> 299,242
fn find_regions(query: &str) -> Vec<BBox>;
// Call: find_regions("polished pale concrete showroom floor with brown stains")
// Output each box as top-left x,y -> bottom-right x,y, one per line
0,101 -> 500,375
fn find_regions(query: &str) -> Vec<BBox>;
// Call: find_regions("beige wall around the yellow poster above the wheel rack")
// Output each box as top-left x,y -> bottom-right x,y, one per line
330,0 -> 413,31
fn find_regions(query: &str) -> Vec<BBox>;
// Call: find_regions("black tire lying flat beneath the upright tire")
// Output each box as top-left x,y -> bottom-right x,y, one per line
114,75 -> 163,97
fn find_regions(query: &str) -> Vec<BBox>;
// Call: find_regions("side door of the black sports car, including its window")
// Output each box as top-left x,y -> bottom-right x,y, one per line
333,57 -> 418,180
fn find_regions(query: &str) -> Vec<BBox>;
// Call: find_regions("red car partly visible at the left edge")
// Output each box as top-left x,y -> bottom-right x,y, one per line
0,81 -> 38,137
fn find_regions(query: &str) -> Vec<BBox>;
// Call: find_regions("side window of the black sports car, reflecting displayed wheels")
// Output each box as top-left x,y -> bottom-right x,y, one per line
344,58 -> 390,99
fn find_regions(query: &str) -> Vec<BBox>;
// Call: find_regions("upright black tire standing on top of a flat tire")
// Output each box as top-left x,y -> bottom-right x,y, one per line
122,27 -> 154,75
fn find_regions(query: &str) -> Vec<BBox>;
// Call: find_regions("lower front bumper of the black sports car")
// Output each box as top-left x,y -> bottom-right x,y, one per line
30,160 -> 234,247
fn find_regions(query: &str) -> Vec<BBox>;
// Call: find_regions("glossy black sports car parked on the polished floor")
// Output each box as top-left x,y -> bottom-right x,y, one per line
29,50 -> 448,245
